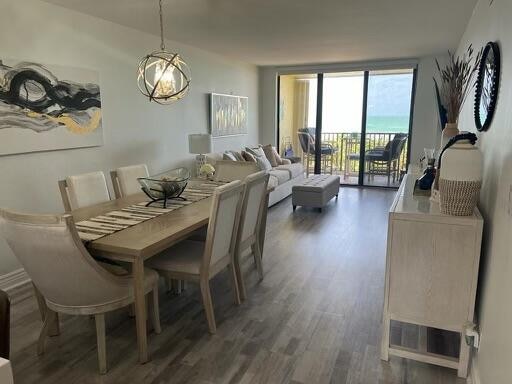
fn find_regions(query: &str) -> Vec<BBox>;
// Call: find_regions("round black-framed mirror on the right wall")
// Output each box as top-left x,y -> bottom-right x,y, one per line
475,42 -> 500,131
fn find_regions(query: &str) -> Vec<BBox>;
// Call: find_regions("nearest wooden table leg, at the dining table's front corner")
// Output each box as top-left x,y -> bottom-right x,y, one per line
133,258 -> 149,364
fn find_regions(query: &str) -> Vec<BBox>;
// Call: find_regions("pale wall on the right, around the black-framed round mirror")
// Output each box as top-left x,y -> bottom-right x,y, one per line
458,0 -> 512,384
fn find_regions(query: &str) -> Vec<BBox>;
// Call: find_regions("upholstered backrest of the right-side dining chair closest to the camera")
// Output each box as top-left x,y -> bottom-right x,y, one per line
201,180 -> 245,273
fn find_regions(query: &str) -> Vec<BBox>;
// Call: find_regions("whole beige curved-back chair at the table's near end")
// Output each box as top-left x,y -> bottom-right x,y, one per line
0,209 -> 161,374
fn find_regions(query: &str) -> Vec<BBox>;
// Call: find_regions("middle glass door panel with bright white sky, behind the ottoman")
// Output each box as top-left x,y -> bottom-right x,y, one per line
321,71 -> 364,185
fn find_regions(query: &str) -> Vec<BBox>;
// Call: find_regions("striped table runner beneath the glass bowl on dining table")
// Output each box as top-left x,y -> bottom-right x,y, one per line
75,181 -> 225,242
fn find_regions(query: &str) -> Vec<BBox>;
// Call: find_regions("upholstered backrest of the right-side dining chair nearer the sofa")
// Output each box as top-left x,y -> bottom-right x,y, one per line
237,172 -> 270,246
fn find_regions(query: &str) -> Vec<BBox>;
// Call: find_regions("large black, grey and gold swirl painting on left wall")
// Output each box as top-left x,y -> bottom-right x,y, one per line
0,60 -> 103,155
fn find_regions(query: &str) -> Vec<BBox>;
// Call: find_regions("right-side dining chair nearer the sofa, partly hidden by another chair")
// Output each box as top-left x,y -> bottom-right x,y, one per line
235,172 -> 269,300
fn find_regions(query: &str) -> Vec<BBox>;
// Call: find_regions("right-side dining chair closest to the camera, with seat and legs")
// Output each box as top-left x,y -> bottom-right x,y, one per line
147,181 -> 245,334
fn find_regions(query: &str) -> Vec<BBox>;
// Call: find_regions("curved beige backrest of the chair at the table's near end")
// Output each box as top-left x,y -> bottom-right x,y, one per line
0,209 -> 130,307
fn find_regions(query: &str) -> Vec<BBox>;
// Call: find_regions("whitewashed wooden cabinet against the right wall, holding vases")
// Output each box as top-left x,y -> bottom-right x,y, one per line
381,175 -> 483,377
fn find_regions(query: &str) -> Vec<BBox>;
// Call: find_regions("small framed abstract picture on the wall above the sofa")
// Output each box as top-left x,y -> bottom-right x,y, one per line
210,93 -> 249,137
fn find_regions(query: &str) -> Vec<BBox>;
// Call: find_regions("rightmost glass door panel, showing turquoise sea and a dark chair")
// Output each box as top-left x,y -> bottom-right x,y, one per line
363,69 -> 414,187
